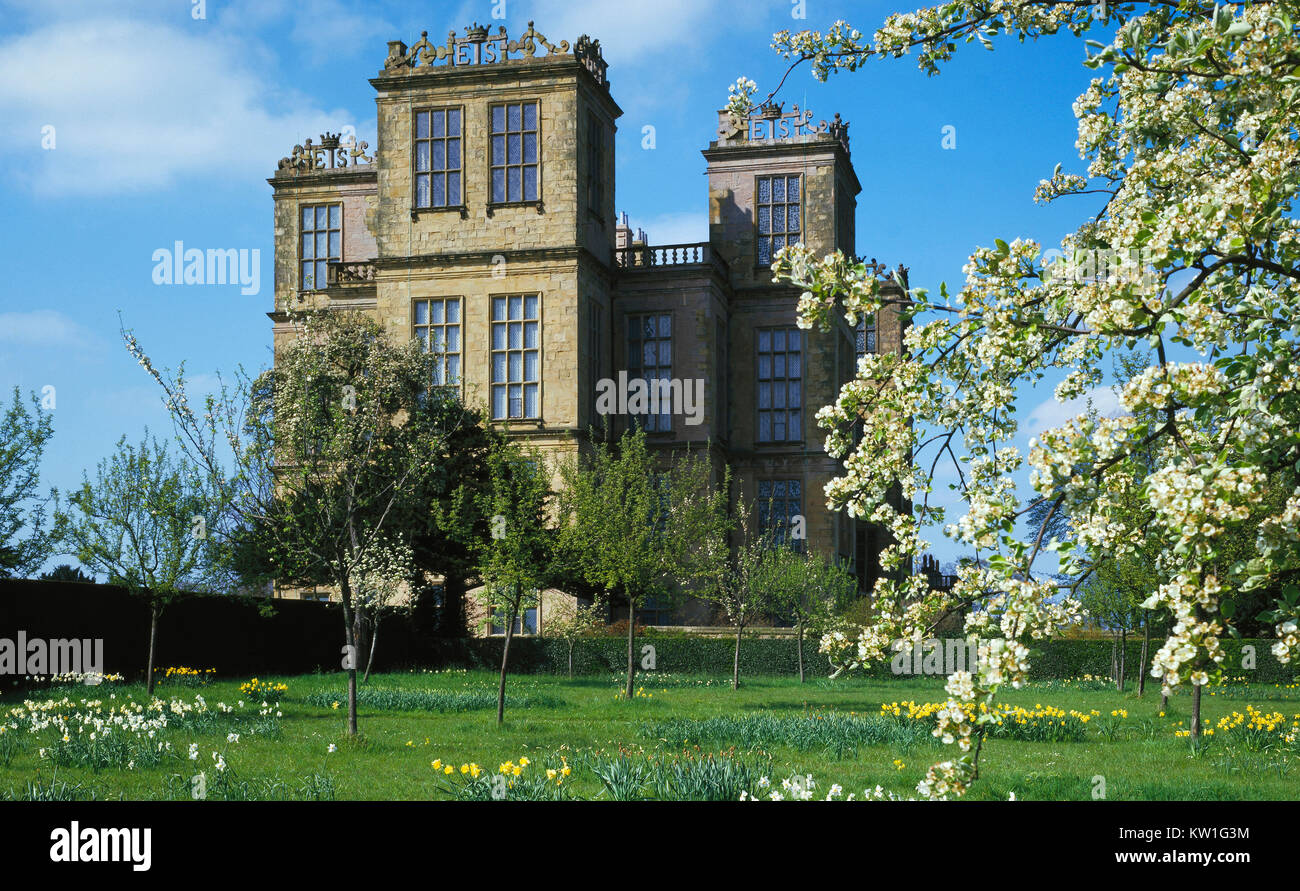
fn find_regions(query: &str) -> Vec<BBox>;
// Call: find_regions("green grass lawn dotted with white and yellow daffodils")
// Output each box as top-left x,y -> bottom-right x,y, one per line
0,671 -> 1300,800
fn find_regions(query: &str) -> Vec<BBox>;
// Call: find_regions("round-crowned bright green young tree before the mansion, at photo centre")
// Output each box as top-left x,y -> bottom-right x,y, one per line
559,431 -> 725,698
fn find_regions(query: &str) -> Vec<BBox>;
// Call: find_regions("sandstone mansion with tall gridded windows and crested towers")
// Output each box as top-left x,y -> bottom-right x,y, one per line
269,23 -> 902,632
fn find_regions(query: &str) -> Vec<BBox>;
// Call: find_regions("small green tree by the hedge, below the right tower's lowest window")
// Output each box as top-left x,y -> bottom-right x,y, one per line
761,545 -> 858,684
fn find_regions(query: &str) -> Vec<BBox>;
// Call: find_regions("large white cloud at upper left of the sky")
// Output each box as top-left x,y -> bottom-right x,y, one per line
0,18 -> 364,195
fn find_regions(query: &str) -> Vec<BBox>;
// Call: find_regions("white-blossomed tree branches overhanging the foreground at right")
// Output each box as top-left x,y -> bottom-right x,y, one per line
731,0 -> 1300,797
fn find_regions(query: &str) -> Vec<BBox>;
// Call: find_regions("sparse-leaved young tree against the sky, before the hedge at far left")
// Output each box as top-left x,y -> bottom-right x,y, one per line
55,432 -> 213,696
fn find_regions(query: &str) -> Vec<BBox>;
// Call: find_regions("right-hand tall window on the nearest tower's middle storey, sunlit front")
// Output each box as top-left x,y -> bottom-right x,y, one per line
491,294 -> 542,420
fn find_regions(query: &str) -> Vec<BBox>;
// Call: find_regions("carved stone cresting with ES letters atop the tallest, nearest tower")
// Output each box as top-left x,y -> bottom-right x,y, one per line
384,22 -> 610,90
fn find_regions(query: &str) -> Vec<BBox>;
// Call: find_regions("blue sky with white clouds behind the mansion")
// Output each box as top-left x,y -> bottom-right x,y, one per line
0,0 -> 1118,569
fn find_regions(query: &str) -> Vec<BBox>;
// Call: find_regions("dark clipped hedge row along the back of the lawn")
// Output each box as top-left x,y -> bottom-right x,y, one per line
0,580 -> 1300,683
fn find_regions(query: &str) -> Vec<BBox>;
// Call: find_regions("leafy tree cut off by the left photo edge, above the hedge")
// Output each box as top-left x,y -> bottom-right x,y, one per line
0,388 -> 55,579
